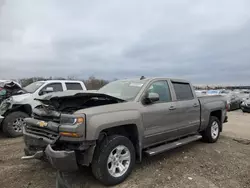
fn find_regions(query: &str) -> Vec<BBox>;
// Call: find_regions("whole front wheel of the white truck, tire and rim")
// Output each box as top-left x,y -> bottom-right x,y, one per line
2,111 -> 29,137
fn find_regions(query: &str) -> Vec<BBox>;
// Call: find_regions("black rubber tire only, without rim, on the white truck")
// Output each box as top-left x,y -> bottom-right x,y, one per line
2,111 -> 29,138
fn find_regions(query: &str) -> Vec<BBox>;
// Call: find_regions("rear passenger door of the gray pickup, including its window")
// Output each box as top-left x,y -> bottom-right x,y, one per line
171,81 -> 200,136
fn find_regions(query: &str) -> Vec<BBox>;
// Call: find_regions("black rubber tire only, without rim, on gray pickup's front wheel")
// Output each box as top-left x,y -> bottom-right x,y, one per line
91,135 -> 135,186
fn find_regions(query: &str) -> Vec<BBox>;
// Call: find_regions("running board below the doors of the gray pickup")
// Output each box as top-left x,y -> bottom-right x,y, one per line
144,135 -> 202,156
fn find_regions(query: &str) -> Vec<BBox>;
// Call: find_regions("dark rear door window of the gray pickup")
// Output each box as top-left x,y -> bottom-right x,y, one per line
172,82 -> 194,100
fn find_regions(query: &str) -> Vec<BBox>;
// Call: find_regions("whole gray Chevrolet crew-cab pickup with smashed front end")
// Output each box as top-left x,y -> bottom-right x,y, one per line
23,78 -> 227,185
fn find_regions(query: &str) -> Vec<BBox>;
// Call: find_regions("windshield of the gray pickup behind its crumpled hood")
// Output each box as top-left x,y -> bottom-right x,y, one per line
99,80 -> 145,101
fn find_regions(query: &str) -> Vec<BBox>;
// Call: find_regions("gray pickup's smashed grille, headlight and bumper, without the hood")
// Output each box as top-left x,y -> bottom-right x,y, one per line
23,108 -> 95,171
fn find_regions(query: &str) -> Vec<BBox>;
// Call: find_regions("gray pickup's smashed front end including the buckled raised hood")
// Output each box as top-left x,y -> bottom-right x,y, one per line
23,92 -> 124,171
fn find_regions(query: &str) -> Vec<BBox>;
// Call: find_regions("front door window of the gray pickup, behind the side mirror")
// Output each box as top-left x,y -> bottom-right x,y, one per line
148,81 -> 172,102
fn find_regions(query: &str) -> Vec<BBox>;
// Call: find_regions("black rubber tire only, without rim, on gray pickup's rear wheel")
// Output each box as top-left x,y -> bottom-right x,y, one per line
202,116 -> 221,143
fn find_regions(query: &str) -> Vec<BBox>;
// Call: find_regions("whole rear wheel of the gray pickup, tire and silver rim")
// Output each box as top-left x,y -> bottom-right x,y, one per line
202,116 -> 221,143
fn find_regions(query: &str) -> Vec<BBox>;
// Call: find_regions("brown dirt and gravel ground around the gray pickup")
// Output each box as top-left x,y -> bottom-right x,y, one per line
0,111 -> 250,188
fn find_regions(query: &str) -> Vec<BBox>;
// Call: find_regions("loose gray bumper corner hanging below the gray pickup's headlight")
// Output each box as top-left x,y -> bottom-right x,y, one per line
45,145 -> 78,172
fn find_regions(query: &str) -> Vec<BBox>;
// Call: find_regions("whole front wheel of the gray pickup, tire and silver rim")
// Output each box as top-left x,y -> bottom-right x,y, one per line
92,135 -> 135,186
